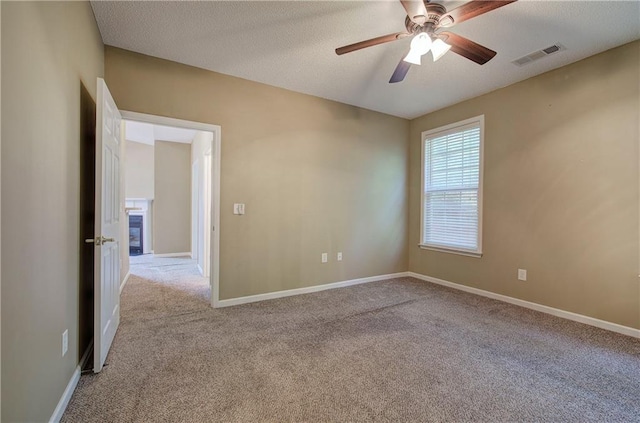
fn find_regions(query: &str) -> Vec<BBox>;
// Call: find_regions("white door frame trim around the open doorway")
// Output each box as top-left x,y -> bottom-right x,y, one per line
120,110 -> 222,307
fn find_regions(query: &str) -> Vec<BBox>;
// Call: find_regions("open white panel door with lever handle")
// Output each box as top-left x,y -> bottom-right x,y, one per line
93,78 -> 122,373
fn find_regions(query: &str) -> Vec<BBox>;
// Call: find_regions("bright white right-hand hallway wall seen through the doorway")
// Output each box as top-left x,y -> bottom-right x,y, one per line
191,131 -> 213,277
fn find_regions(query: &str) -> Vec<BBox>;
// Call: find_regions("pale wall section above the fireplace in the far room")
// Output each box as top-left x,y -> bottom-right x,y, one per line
125,141 -> 154,198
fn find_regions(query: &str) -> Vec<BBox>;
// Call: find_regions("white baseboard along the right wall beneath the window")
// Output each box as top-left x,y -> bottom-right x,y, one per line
408,272 -> 640,338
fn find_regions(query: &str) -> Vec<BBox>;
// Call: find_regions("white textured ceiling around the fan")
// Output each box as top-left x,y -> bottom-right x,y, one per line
92,0 -> 640,118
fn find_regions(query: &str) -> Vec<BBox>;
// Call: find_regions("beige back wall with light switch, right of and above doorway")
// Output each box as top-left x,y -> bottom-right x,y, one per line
105,47 -> 409,299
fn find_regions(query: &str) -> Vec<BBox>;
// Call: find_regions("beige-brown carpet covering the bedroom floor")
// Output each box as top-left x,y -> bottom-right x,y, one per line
62,269 -> 640,422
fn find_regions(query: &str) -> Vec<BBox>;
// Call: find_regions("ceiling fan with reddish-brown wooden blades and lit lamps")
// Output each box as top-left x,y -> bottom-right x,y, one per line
336,0 -> 516,83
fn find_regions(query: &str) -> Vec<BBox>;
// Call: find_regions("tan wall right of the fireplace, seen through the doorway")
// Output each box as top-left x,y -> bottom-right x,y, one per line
154,142 -> 191,254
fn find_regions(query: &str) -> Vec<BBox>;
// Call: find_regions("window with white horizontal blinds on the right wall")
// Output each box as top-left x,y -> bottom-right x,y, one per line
420,116 -> 484,257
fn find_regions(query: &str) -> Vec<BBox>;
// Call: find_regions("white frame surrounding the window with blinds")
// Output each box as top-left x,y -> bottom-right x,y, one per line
419,115 -> 484,258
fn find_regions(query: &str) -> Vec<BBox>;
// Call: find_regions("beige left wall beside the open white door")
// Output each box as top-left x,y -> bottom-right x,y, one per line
0,2 -> 103,422
